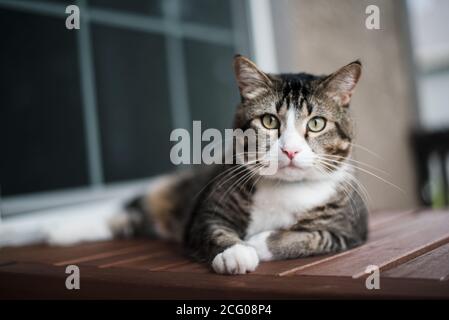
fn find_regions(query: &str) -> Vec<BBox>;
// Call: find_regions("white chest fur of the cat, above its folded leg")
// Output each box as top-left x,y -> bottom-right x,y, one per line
247,180 -> 337,238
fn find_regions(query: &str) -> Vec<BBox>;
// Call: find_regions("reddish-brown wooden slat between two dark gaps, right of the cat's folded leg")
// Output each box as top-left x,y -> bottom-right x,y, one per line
295,212 -> 449,277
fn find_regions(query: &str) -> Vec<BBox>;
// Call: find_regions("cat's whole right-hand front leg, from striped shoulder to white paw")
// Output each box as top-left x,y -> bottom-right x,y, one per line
247,194 -> 367,261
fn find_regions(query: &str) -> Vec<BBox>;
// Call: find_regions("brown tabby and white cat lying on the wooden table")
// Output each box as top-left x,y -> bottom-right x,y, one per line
112,55 -> 368,274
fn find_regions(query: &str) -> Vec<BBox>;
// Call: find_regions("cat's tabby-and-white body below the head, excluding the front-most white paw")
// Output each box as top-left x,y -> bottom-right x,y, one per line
120,159 -> 367,273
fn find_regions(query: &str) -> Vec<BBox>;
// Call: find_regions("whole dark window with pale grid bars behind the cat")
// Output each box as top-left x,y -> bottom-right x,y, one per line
0,0 -> 250,215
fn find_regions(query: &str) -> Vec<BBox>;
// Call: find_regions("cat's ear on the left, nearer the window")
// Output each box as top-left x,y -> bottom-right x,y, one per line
234,55 -> 272,100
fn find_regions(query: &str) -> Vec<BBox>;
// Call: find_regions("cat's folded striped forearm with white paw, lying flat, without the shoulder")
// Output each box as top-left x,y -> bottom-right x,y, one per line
247,230 -> 348,261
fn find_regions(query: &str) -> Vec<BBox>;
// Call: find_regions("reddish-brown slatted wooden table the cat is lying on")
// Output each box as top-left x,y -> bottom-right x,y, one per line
0,210 -> 449,299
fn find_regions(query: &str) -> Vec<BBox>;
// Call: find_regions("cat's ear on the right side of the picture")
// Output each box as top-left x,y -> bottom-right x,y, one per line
320,60 -> 362,106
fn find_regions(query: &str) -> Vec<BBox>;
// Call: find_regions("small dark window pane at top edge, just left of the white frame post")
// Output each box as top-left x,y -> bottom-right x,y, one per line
180,0 -> 232,28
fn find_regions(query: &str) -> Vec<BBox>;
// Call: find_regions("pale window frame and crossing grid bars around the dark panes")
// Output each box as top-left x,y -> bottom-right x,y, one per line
0,0 -> 277,219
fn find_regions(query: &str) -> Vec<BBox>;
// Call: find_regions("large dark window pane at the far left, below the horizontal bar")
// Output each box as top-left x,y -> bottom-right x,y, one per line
0,10 -> 88,195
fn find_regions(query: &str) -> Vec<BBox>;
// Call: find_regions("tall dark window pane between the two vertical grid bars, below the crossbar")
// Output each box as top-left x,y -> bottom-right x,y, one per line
92,25 -> 171,181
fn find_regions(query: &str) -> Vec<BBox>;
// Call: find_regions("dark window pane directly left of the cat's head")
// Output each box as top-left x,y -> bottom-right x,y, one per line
184,40 -> 239,130
